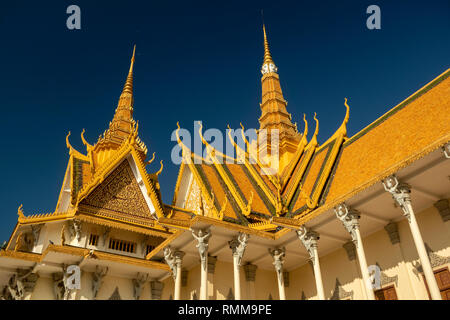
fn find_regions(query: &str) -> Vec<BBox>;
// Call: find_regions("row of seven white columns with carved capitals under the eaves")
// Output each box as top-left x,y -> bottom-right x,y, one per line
164,172 -> 441,300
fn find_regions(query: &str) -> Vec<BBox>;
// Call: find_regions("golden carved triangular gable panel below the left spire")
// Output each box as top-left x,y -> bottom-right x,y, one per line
81,160 -> 151,219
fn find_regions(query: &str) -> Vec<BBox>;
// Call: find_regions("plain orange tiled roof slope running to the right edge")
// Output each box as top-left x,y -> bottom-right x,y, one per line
326,69 -> 450,203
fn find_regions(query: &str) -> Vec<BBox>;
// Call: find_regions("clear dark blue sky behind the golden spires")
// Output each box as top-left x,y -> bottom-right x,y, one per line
0,0 -> 450,241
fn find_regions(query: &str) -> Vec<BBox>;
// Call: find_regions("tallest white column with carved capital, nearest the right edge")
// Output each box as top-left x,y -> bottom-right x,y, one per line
383,175 -> 442,300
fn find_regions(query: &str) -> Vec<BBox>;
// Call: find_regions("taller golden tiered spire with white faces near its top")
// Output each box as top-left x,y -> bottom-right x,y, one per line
259,24 -> 300,171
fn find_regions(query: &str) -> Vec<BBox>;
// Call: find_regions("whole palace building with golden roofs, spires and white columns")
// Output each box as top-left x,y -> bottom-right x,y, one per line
0,27 -> 450,300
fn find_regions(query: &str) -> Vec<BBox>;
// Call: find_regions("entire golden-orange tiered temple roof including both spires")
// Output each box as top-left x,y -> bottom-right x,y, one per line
3,24 -> 450,255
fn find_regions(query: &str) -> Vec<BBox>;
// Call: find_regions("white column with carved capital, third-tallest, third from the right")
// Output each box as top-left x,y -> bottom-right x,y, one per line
297,226 -> 325,300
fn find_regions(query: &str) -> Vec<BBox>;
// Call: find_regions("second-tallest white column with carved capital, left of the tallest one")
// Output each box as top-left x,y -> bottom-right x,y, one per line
334,203 -> 375,300
